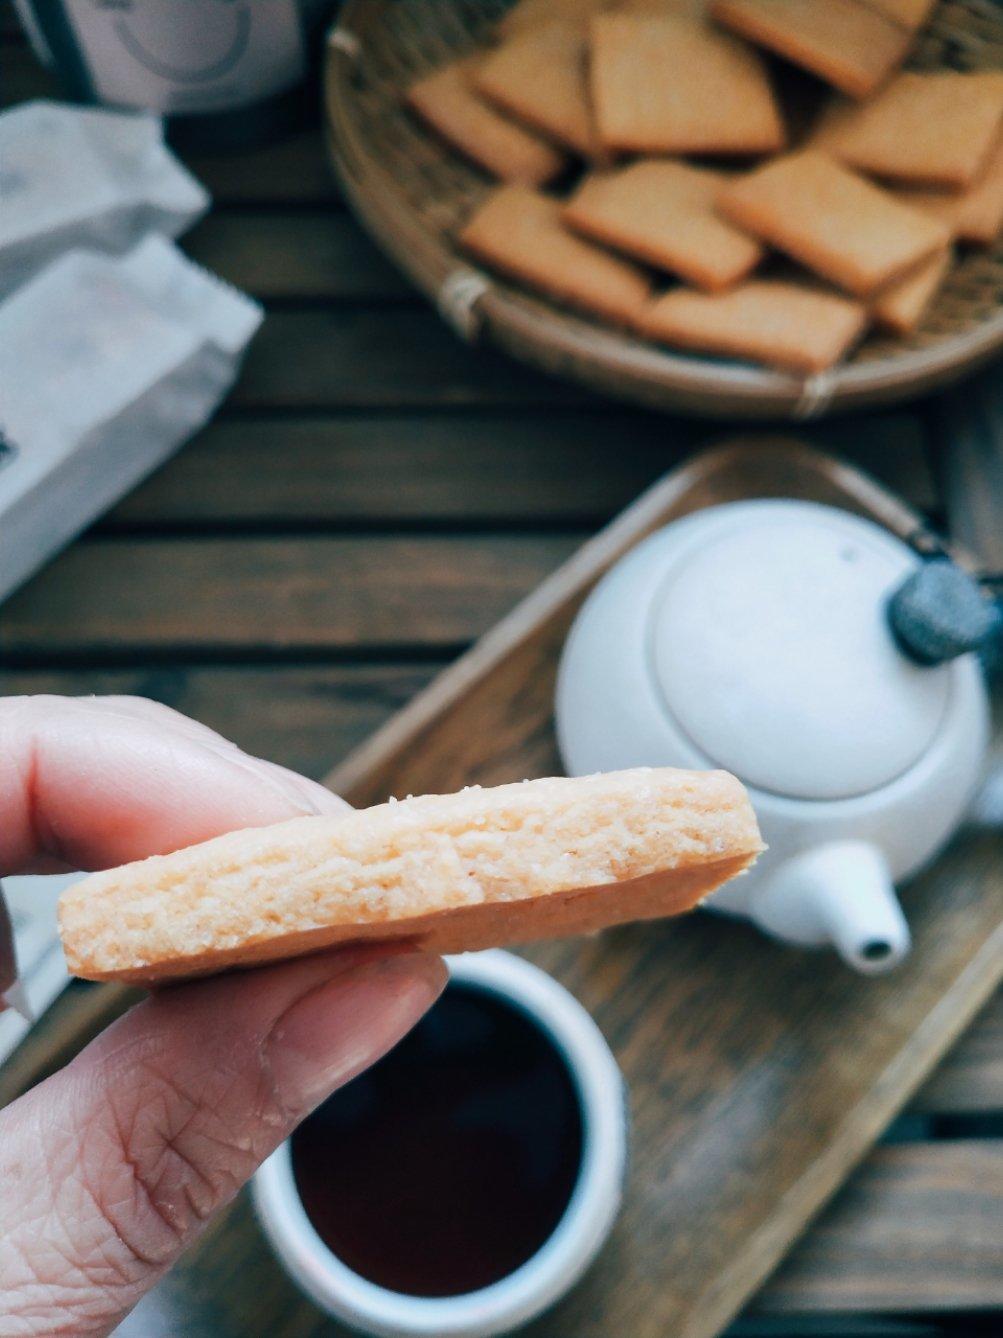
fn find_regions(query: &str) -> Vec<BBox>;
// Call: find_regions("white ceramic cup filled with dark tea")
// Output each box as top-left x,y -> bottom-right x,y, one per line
253,949 -> 627,1338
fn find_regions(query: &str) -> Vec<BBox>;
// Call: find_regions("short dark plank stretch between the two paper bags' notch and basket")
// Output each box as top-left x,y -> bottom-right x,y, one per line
183,210 -> 409,305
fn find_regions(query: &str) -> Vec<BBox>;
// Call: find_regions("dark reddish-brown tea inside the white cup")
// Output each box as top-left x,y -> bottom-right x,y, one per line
292,982 -> 583,1297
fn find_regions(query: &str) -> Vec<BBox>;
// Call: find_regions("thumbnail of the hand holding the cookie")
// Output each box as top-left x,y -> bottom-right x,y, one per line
265,953 -> 448,1116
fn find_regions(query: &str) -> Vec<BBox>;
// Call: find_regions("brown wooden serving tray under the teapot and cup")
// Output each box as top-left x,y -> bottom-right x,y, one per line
328,442 -> 1003,1338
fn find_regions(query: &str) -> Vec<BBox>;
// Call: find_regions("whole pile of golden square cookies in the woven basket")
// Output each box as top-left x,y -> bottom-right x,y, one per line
407,0 -> 1003,375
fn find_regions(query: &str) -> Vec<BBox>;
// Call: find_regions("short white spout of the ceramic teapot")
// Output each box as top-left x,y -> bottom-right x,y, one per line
752,840 -> 909,975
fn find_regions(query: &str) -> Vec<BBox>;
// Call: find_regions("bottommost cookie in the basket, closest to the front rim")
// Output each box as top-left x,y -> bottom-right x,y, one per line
643,278 -> 867,373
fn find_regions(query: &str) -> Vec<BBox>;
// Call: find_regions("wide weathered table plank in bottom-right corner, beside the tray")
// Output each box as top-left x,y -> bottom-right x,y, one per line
757,1140 -> 1003,1313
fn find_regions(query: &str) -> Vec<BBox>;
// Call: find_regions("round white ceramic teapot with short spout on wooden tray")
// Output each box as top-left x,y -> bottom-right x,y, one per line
556,500 -> 991,971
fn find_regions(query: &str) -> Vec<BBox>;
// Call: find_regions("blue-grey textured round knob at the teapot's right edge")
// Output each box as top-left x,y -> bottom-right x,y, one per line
888,558 -> 1000,665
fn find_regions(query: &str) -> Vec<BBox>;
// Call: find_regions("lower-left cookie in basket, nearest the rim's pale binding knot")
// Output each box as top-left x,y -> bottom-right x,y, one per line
459,186 -> 651,325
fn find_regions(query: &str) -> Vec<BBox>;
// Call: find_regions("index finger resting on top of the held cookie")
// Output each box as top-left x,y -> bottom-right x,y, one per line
0,697 -> 345,876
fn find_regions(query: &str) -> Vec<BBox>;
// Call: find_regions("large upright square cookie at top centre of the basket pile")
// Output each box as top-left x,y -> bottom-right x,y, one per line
591,12 -> 785,154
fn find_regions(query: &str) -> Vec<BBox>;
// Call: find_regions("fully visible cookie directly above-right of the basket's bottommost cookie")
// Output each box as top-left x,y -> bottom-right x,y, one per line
718,150 -> 951,297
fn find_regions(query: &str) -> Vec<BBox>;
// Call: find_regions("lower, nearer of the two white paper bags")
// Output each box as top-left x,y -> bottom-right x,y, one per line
0,237 -> 262,598
